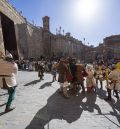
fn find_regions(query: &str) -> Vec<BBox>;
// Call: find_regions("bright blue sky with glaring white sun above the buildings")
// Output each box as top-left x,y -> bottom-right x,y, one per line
9,0 -> 120,46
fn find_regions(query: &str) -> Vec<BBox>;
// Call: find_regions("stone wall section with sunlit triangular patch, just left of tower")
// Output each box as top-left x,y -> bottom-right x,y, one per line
27,24 -> 43,58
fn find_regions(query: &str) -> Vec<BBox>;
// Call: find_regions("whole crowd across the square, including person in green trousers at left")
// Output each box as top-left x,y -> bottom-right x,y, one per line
0,52 -> 120,112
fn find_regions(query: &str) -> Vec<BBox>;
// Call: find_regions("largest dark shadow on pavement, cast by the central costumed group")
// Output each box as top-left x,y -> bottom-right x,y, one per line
26,91 -> 101,129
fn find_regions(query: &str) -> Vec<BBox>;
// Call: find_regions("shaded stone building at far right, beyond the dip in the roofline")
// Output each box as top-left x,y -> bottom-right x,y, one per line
86,35 -> 120,62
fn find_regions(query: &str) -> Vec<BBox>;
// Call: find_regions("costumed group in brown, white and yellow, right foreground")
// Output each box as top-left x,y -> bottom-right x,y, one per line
53,58 -> 120,101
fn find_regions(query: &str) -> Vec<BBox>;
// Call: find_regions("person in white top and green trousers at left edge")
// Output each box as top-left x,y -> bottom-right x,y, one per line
0,53 -> 18,112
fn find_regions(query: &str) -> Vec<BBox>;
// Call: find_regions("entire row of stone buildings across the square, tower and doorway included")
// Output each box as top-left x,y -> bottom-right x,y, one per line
0,0 -> 120,62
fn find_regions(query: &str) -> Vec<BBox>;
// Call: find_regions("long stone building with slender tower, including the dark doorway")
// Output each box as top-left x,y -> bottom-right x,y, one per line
0,0 -> 84,59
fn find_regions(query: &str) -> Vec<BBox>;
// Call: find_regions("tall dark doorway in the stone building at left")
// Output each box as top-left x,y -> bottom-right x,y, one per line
0,13 -> 18,60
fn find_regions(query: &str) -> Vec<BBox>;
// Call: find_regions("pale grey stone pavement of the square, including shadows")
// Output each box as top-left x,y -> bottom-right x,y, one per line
0,71 -> 120,129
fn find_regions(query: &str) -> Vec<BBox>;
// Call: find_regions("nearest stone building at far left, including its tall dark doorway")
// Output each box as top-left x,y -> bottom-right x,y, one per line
0,0 -> 28,58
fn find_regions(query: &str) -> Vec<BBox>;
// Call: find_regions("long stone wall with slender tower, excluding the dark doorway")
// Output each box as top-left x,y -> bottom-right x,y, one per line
0,0 -> 92,59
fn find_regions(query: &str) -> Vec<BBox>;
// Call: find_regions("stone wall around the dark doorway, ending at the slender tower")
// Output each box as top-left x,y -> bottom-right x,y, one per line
0,0 -> 43,59
